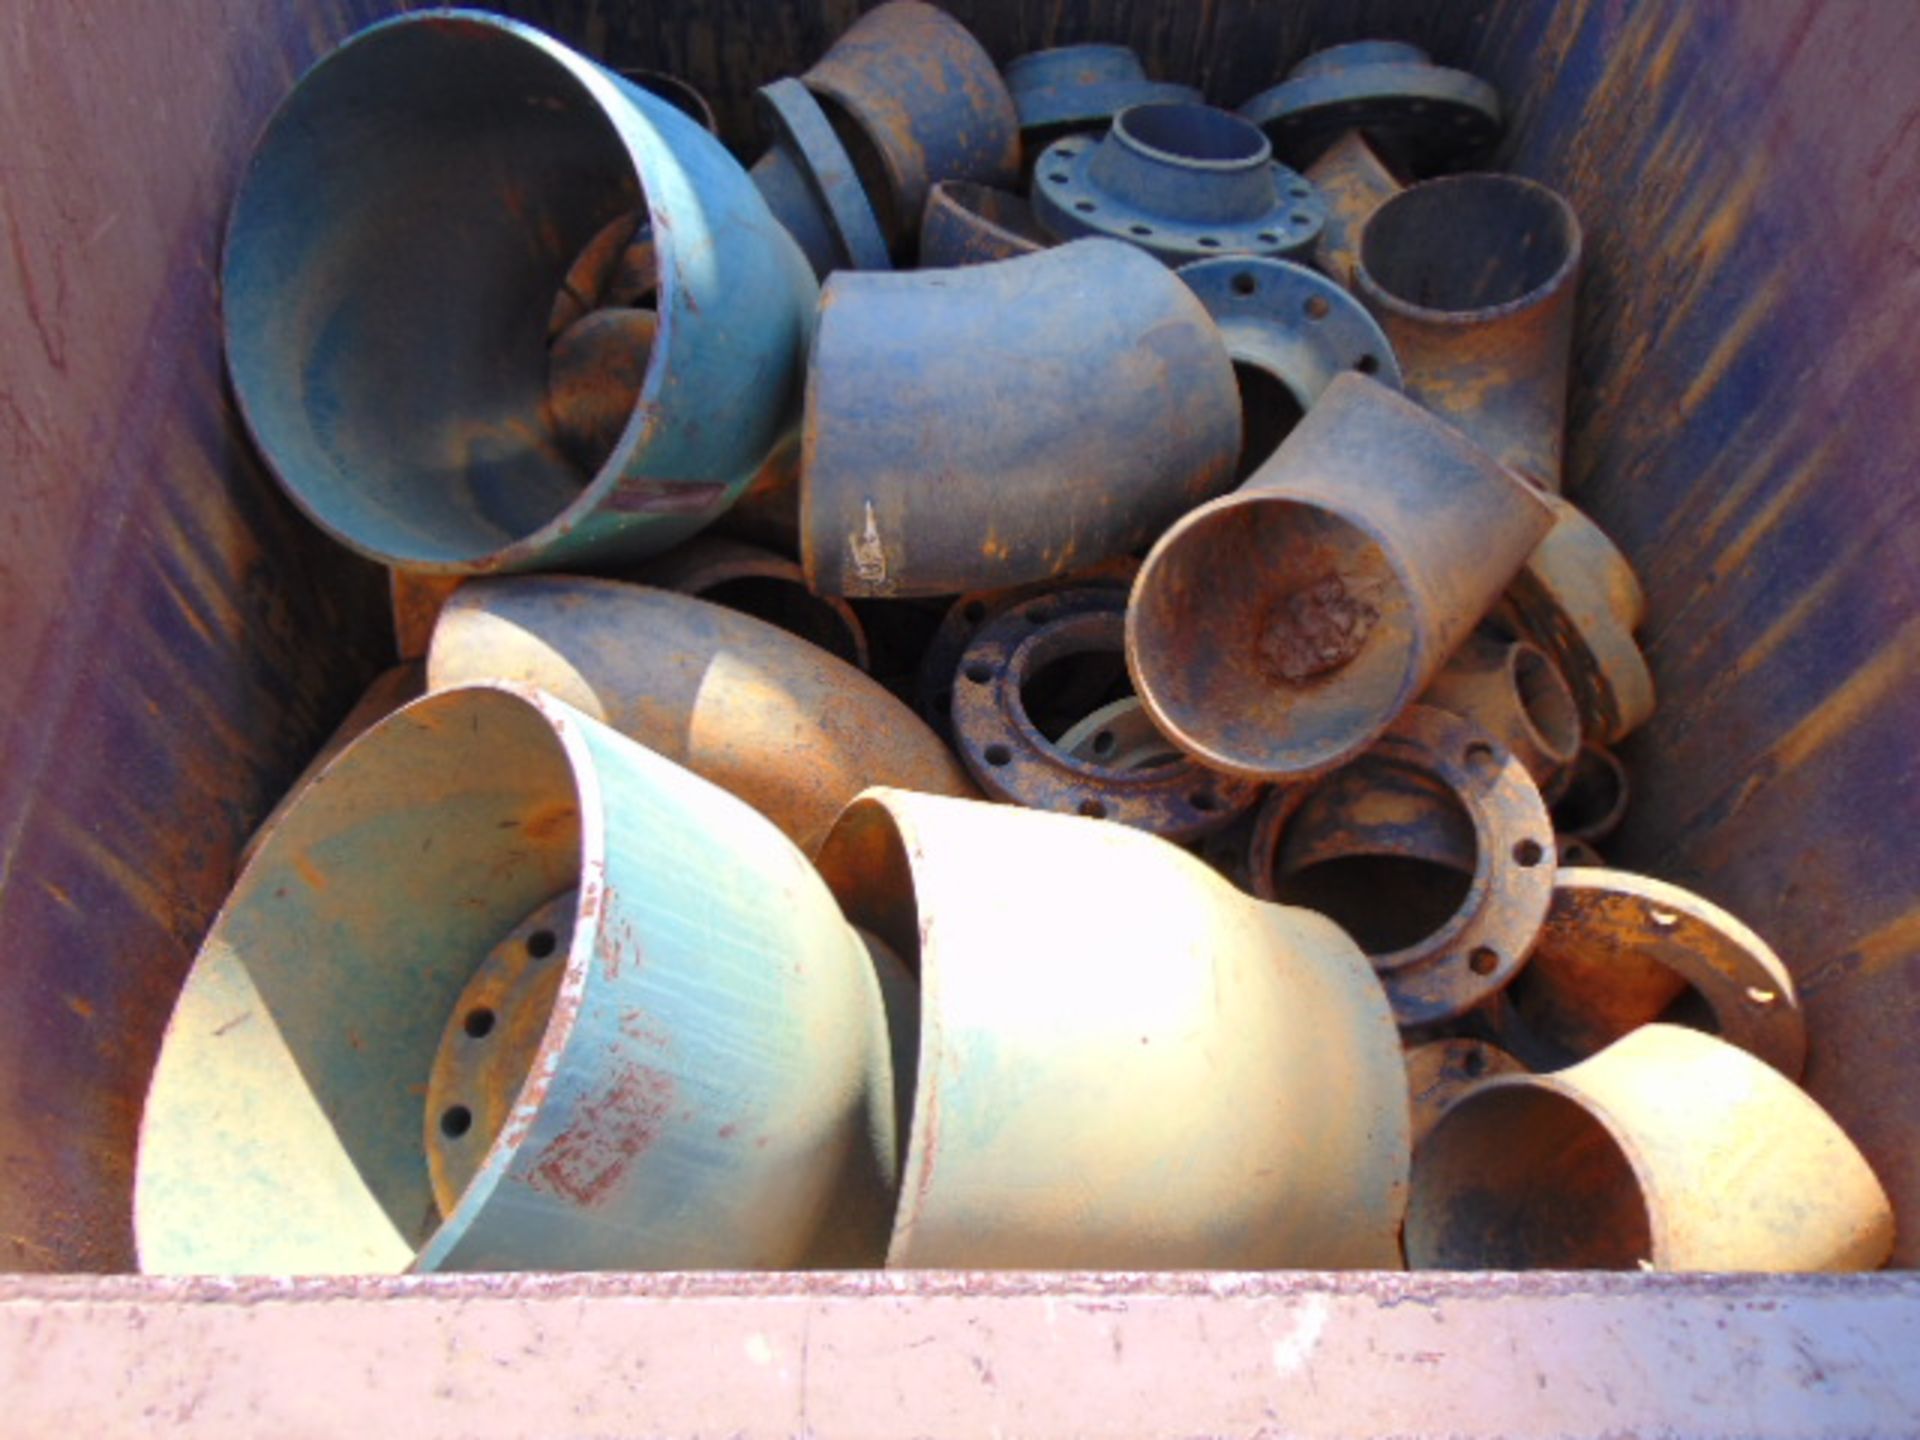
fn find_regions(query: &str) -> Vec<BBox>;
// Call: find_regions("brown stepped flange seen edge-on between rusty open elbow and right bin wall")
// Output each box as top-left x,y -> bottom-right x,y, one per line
1498,495 -> 1653,744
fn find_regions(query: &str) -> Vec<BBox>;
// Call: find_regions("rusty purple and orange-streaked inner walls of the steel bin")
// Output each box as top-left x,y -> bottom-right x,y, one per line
0,0 -> 1920,1284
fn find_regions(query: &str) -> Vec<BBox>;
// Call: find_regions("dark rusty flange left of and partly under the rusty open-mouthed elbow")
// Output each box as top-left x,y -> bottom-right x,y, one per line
952,589 -> 1261,841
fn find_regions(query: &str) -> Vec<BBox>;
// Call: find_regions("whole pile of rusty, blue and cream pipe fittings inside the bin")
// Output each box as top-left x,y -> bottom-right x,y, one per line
134,0 -> 1893,1273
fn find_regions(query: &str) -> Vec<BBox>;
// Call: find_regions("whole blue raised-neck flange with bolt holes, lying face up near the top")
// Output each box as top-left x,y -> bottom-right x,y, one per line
1033,104 -> 1327,265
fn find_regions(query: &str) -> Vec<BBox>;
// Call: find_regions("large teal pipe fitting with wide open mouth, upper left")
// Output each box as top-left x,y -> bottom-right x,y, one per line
223,12 -> 818,572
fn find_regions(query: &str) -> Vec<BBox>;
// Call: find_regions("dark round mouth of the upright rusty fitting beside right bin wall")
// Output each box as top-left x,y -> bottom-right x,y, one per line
1359,175 -> 1580,315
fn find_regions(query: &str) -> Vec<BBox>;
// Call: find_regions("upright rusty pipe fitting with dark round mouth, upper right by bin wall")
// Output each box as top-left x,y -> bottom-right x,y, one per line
1354,175 -> 1580,492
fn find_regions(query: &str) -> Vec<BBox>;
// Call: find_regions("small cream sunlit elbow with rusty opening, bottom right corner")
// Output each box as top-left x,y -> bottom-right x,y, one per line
1405,1025 -> 1893,1271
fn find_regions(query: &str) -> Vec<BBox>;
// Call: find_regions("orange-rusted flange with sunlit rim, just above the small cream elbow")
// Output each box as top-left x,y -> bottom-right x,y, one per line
1488,868 -> 1807,1079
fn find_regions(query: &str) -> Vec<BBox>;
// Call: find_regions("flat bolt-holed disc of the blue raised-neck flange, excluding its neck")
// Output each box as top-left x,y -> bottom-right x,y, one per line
1033,134 -> 1327,265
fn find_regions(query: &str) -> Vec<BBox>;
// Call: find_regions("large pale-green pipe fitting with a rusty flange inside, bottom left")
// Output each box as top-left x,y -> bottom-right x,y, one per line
134,685 -> 897,1275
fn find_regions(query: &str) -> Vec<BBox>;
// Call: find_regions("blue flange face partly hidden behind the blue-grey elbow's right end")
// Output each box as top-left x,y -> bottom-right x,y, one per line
1177,255 -> 1402,411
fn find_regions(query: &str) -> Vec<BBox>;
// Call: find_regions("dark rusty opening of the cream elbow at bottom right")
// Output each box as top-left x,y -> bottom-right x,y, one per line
1405,1081 -> 1653,1269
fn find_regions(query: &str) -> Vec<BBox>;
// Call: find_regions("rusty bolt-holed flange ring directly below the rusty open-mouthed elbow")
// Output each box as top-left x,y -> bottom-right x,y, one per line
1252,705 -> 1555,1029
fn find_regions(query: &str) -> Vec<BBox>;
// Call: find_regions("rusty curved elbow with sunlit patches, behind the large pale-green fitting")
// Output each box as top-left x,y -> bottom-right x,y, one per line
426,576 -> 975,852
